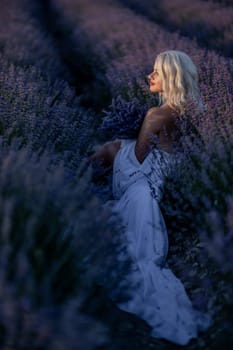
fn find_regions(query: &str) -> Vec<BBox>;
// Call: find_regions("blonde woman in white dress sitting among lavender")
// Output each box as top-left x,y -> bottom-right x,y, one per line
90,50 -> 212,345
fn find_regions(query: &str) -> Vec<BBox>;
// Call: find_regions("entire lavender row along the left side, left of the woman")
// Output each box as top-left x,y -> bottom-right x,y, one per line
0,0 -> 130,350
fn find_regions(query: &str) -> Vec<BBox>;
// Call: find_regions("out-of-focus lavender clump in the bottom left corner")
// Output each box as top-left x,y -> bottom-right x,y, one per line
0,267 -> 108,350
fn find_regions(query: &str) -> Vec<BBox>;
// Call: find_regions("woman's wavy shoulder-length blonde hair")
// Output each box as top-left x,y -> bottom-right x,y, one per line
154,50 -> 205,115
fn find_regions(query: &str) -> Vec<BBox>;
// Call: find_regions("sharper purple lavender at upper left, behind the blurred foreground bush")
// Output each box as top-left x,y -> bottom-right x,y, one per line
0,0 -> 94,169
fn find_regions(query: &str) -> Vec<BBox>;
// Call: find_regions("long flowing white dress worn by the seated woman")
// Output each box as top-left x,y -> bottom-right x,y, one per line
106,139 -> 212,345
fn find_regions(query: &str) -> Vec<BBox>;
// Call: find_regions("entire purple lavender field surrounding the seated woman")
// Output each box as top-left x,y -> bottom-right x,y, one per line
0,0 -> 233,350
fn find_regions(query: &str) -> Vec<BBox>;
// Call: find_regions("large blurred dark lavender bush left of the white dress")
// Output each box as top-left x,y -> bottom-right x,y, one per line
0,142 -> 132,349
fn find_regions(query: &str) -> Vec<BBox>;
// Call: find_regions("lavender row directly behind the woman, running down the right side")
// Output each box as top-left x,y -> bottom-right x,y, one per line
52,0 -> 233,341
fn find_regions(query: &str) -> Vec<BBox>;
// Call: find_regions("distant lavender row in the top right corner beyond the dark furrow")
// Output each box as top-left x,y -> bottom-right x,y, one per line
117,0 -> 233,57
